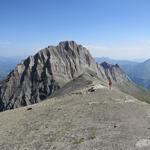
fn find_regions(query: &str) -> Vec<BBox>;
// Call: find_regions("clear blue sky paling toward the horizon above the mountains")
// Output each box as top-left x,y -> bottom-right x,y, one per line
0,0 -> 150,59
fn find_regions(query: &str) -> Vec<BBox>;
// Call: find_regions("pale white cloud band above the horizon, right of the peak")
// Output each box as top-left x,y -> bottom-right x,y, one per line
86,45 -> 150,59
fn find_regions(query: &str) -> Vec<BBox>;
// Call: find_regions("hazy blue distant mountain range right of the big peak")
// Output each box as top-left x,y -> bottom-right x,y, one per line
95,57 -> 150,89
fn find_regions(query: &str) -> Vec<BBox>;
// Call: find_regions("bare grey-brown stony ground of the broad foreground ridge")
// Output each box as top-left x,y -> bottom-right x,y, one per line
0,85 -> 150,150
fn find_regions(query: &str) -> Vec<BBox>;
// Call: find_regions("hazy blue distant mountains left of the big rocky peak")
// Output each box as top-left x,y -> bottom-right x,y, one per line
0,56 -> 23,80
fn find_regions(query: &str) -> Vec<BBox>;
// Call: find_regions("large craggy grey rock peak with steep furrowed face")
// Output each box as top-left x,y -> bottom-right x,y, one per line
0,41 -> 129,111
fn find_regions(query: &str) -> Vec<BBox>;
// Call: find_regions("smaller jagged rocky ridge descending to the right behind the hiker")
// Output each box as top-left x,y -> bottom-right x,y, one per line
101,62 -> 150,103
